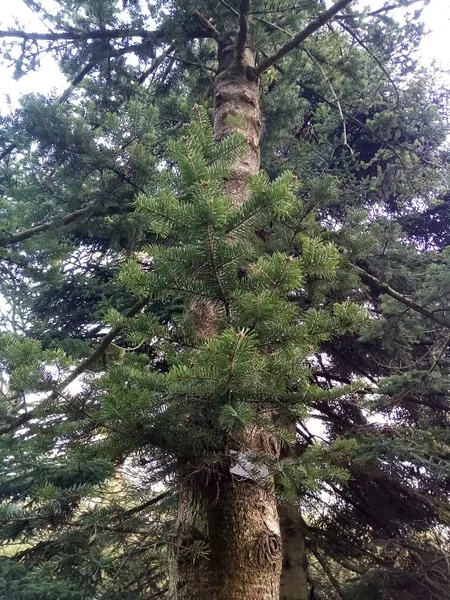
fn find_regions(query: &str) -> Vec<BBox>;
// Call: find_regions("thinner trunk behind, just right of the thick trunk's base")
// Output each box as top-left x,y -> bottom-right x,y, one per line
278,506 -> 308,600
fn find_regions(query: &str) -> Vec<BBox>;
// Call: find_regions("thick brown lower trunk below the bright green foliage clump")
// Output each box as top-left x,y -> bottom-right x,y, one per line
172,473 -> 282,600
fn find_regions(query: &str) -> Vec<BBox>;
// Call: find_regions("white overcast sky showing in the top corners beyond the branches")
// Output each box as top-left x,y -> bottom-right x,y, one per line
0,0 -> 450,113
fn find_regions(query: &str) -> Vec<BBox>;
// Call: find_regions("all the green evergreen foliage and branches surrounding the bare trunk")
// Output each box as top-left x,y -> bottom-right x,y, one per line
0,0 -> 450,600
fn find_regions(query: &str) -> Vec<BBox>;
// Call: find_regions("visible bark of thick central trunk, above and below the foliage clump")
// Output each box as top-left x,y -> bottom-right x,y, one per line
172,43 -> 282,600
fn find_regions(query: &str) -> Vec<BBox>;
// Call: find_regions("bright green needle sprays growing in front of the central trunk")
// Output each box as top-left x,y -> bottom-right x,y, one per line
107,107 -> 366,464
